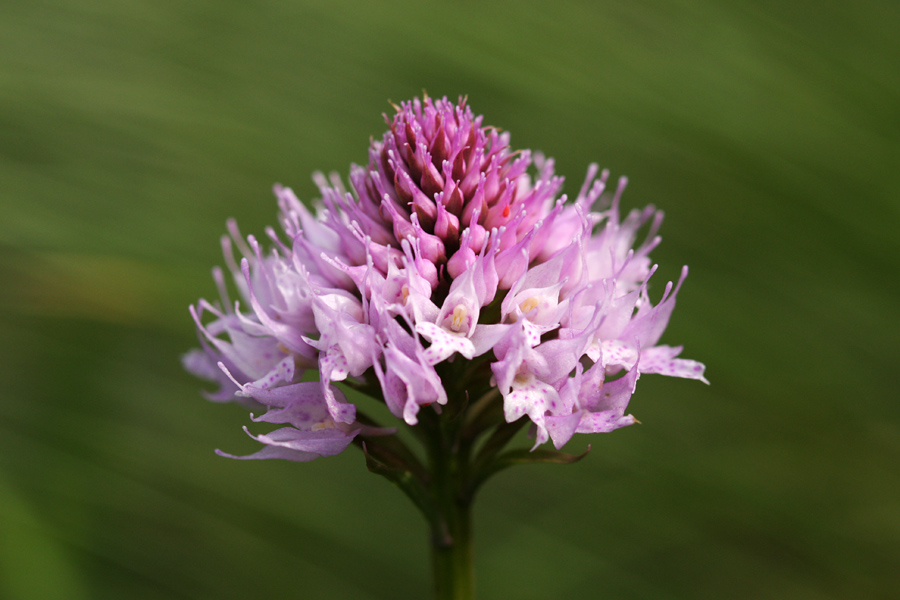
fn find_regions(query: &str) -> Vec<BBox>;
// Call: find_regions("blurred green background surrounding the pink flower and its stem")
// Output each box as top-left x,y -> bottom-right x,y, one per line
0,0 -> 900,600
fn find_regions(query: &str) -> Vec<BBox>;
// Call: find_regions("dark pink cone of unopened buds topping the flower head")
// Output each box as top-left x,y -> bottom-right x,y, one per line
353,97 -> 562,285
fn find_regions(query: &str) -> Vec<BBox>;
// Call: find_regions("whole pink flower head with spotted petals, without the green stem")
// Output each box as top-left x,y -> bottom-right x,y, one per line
184,97 -> 706,460
